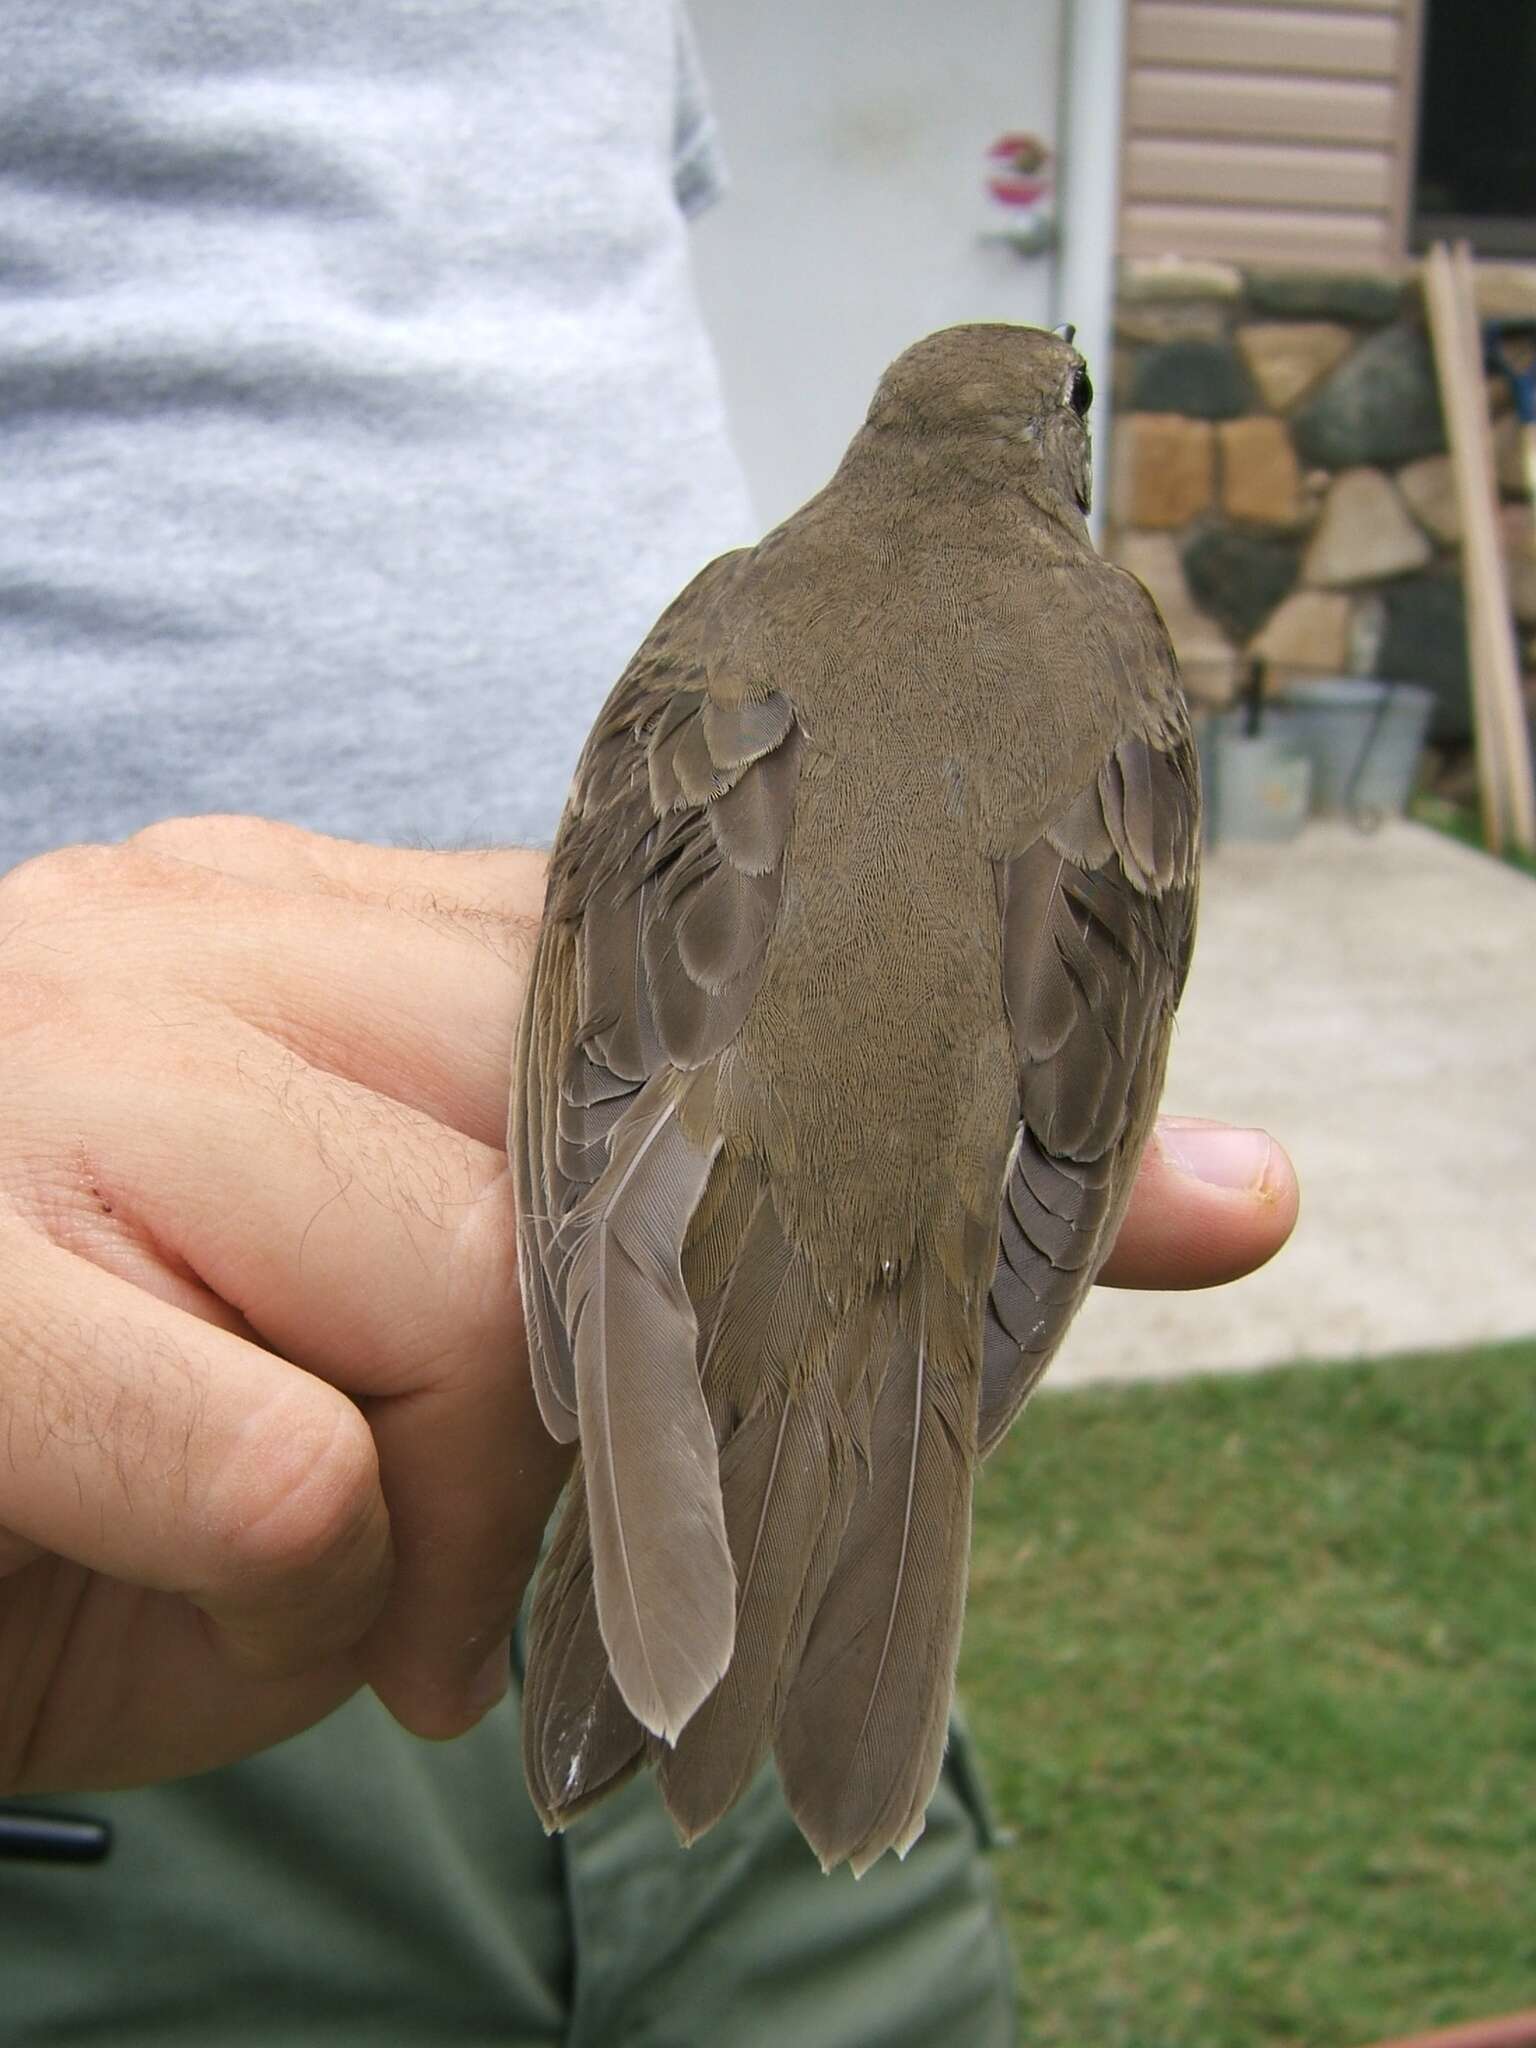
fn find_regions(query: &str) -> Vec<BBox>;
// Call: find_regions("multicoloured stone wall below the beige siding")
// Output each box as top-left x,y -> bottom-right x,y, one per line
1106,260 -> 1536,748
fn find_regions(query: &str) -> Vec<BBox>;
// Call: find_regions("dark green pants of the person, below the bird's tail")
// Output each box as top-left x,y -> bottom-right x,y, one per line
0,1698 -> 1014,2048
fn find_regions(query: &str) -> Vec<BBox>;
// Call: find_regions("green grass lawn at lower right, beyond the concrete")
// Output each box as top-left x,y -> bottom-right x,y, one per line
961,1341 -> 1536,2048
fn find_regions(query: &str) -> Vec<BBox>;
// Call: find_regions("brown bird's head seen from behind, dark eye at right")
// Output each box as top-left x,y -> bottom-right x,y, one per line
866,324 -> 1094,522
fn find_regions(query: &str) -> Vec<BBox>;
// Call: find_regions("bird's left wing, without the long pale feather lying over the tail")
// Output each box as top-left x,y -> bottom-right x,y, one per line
510,553 -> 801,1442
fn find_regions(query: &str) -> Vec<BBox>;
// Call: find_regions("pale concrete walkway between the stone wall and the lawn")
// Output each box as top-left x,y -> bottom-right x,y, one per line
1051,823 -> 1536,1386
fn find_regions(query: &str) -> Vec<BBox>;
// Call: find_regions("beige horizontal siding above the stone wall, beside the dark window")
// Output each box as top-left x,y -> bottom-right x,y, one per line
1120,0 -> 1419,268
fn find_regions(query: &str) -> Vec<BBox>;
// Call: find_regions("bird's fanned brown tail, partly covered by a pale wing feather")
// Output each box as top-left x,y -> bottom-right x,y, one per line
524,1122 -> 977,1872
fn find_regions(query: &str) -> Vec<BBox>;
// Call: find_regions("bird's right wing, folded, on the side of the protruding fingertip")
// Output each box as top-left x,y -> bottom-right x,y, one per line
979,651 -> 1200,1454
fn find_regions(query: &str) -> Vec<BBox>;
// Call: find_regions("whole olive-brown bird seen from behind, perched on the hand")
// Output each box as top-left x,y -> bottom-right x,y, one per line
508,324 -> 1200,1876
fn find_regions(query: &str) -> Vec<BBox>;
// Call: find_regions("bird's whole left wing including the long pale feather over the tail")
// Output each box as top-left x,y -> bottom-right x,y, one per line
510,555 -> 801,1739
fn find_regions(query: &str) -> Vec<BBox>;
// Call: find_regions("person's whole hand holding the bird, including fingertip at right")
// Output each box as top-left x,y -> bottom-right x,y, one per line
0,819 -> 1296,1792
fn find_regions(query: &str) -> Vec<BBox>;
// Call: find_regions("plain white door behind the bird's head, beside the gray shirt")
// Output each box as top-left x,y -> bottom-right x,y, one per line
690,0 -> 1064,522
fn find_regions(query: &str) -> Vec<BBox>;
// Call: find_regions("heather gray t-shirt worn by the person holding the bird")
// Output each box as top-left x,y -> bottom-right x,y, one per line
0,0 -> 750,868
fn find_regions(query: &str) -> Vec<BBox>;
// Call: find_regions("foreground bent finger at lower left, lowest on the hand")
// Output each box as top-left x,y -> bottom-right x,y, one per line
0,1219 -> 391,1675
